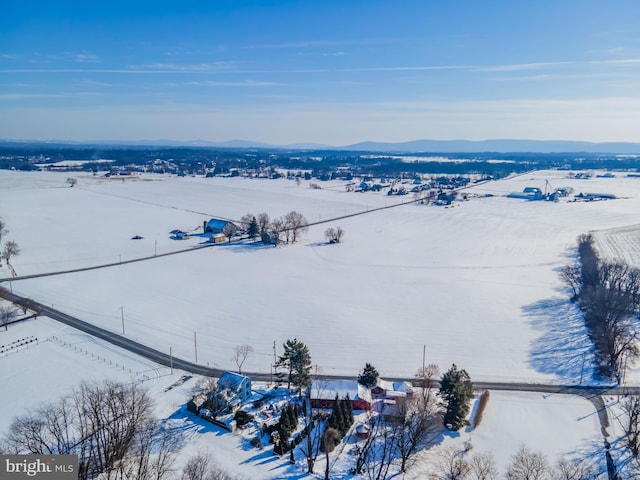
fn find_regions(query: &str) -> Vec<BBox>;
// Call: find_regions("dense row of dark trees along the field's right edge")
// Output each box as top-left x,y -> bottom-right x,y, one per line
561,235 -> 640,382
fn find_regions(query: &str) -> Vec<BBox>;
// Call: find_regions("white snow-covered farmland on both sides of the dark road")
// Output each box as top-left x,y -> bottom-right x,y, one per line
0,170 -> 640,478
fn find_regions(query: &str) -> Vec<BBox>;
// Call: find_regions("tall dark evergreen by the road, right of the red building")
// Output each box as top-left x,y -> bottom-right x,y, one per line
440,364 -> 473,431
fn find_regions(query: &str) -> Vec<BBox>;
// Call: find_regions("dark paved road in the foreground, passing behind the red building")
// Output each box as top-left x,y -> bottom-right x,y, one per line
0,287 -> 640,399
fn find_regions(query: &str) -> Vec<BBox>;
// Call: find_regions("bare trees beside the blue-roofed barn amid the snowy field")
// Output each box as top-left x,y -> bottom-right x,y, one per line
240,210 -> 309,245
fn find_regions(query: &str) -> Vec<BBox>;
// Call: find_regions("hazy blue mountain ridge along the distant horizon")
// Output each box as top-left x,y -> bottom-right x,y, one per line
0,139 -> 640,155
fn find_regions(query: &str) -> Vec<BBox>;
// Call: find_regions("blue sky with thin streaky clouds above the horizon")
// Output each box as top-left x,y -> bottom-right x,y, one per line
0,0 -> 640,145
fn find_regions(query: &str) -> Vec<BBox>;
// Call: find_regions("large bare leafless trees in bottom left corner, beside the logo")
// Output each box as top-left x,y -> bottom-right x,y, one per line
4,382 -> 165,480
